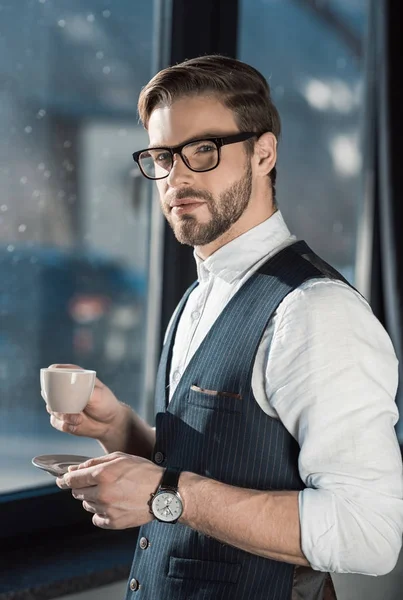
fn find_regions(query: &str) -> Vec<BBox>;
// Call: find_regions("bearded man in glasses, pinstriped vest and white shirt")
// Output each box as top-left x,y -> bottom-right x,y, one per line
51,56 -> 403,600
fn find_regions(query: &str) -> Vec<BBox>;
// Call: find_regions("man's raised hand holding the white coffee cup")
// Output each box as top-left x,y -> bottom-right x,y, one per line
46,364 -> 125,441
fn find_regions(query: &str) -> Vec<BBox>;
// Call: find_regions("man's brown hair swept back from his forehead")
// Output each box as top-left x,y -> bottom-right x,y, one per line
138,55 -> 281,205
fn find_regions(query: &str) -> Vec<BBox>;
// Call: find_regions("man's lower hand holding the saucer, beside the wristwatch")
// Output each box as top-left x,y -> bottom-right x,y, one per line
56,452 -> 164,529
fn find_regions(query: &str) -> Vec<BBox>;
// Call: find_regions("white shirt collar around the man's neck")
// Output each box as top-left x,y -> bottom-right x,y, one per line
193,210 -> 291,283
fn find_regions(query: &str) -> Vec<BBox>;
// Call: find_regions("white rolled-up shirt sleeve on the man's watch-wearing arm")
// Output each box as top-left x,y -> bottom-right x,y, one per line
266,280 -> 403,575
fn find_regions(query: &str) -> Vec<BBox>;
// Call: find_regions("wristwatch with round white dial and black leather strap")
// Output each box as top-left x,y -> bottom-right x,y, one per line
149,467 -> 183,523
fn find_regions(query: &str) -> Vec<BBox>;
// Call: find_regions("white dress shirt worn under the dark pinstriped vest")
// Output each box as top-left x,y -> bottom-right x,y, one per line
168,211 -> 403,575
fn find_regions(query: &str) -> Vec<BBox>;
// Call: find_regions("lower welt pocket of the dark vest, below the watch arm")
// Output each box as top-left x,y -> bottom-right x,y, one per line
168,556 -> 241,583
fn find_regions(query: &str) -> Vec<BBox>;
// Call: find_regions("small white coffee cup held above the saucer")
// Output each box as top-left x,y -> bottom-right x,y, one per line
41,367 -> 96,414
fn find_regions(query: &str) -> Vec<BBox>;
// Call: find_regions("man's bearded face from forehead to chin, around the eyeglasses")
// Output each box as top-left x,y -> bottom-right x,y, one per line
148,96 -> 252,246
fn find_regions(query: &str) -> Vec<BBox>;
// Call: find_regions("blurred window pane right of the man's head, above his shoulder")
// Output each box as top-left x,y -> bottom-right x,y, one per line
239,0 -> 368,282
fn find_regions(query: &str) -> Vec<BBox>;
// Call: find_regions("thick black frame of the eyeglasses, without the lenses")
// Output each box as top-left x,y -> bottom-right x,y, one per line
132,131 -> 260,181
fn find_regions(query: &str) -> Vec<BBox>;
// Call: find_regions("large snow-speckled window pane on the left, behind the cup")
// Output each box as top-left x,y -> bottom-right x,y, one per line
0,0 -> 154,492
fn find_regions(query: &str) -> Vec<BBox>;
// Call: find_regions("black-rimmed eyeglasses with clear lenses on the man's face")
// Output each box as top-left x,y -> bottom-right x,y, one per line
132,132 -> 258,180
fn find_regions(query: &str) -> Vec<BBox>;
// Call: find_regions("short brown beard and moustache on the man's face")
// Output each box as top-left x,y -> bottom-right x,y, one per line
163,162 -> 252,246
